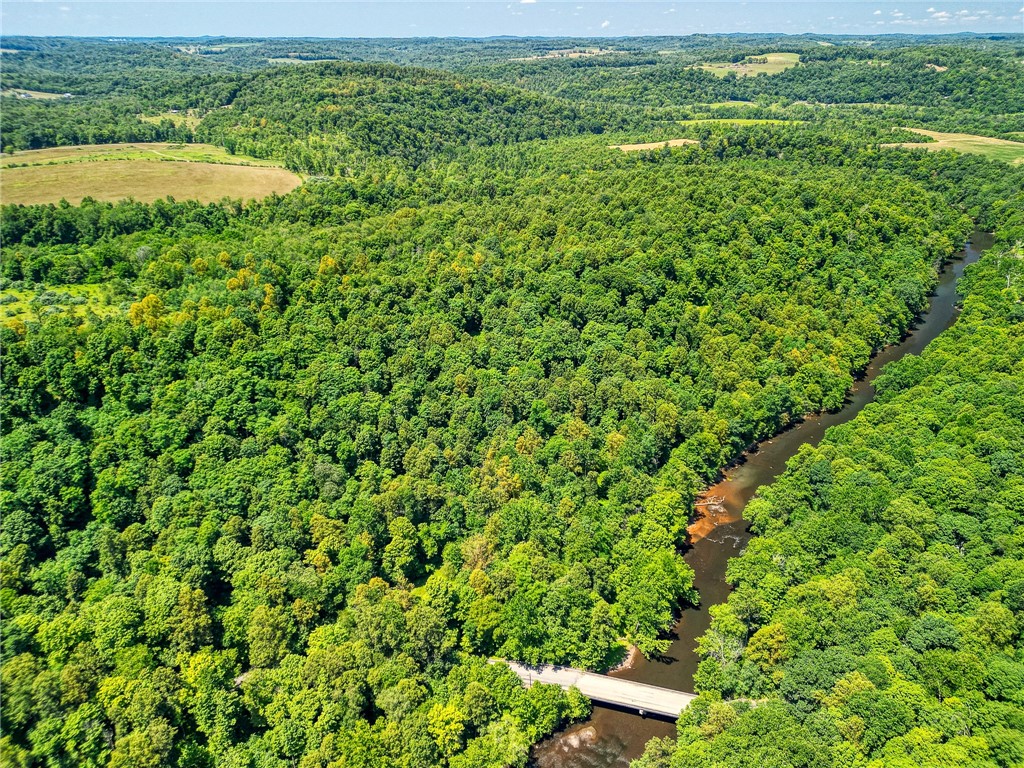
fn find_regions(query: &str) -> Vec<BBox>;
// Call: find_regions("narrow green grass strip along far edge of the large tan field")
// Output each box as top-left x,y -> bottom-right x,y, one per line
0,142 -> 281,168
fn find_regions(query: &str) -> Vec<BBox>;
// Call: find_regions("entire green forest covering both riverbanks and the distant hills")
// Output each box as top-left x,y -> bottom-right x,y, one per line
0,37 -> 1024,768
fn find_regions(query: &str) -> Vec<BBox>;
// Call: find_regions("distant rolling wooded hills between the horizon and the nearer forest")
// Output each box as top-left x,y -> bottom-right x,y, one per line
3,35 -> 1024,159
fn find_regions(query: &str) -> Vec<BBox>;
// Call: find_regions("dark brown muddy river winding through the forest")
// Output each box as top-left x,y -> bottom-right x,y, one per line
532,232 -> 992,768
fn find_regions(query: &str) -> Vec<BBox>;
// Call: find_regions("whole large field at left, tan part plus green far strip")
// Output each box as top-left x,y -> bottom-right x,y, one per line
0,143 -> 302,205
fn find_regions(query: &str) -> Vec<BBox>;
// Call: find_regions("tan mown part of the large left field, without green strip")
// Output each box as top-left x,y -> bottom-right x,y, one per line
0,160 -> 302,205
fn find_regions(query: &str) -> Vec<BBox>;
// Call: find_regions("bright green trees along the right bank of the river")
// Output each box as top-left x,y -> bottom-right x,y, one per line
635,211 -> 1024,768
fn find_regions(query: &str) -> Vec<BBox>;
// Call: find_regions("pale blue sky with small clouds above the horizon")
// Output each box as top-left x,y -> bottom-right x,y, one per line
0,0 -> 1024,37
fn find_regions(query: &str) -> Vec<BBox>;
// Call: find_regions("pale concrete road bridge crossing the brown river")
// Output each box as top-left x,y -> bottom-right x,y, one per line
492,659 -> 696,718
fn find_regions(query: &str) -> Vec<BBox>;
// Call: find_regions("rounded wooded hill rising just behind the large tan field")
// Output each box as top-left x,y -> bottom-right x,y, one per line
191,63 -> 603,174
